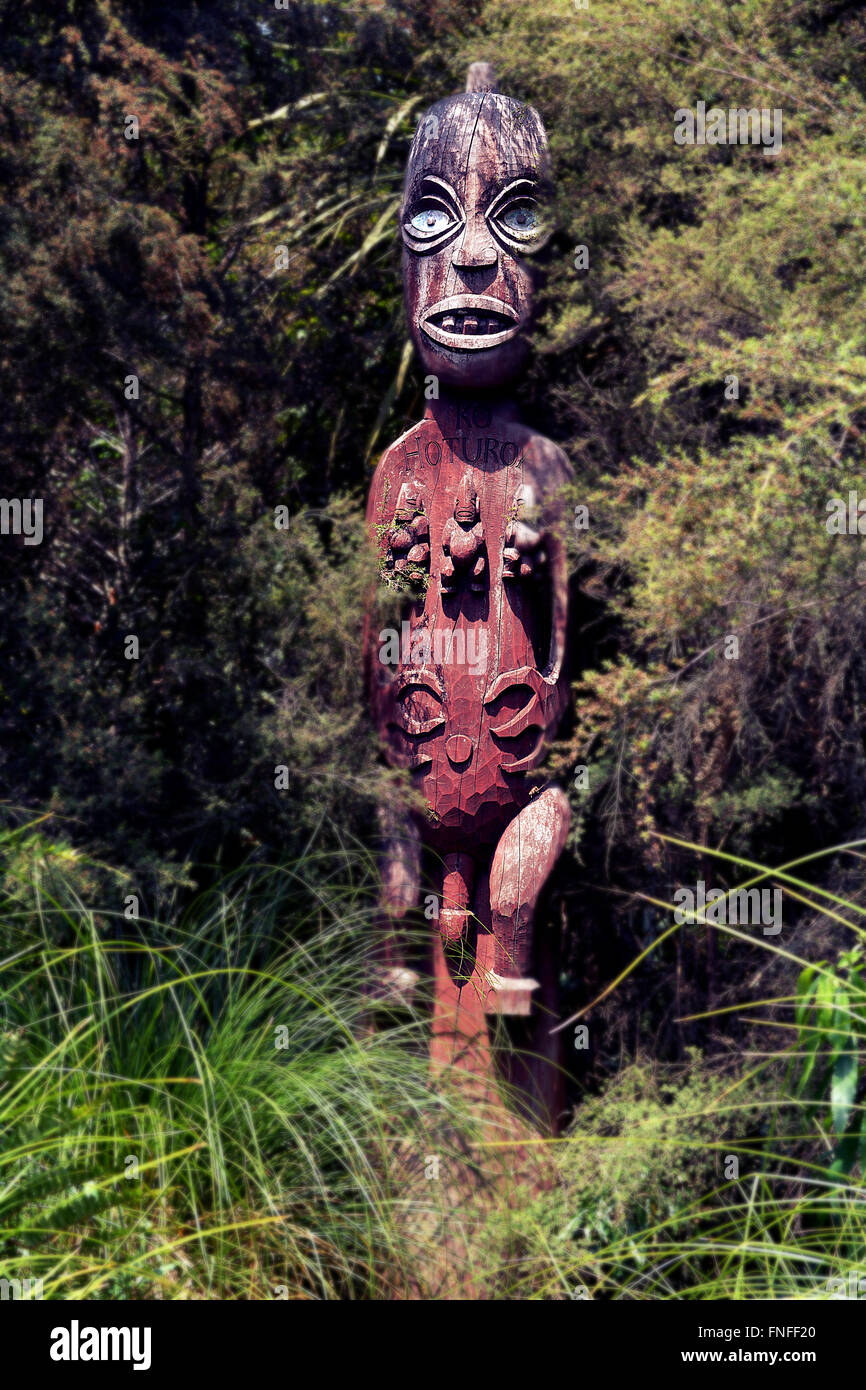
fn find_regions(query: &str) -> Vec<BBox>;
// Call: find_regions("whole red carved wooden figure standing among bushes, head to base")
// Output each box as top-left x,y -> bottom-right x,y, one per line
367,64 -> 571,1123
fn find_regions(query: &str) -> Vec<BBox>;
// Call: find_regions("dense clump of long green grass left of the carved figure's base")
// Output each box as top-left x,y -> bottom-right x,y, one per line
0,826 -> 489,1298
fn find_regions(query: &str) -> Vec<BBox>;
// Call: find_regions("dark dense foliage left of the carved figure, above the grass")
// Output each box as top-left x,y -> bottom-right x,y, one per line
0,3 -> 450,874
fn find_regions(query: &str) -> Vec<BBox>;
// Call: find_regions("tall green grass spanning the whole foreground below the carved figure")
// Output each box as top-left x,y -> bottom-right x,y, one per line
6,826 -> 866,1301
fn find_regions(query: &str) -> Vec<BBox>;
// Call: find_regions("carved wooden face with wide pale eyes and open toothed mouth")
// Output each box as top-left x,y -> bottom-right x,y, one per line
402,92 -> 549,389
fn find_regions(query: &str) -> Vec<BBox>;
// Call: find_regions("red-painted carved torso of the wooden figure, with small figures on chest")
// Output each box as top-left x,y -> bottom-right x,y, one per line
368,402 -> 570,852
